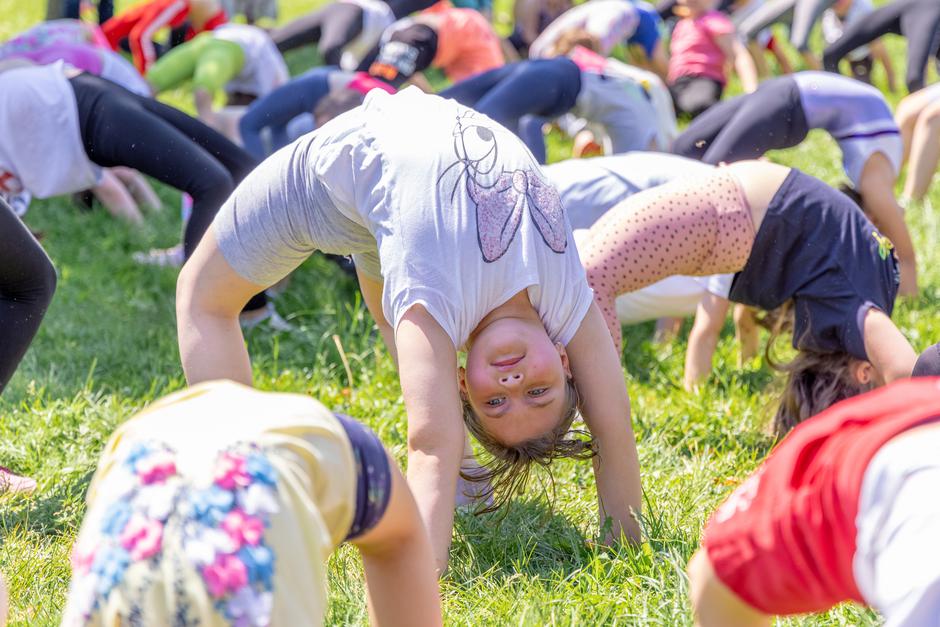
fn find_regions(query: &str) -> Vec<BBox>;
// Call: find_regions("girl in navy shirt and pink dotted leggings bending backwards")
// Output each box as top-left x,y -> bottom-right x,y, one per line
582,161 -> 916,433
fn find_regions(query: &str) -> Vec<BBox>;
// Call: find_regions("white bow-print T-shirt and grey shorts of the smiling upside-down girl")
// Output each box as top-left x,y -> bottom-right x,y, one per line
213,87 -> 593,347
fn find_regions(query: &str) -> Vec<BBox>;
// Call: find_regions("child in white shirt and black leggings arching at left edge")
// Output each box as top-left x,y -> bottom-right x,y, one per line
0,64 -> 268,319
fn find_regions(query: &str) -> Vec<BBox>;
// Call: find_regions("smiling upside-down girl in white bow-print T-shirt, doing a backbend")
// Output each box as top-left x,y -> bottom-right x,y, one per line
177,88 -> 640,569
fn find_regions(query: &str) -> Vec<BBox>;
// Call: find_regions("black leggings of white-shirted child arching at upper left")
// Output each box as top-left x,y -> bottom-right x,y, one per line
69,74 -> 266,310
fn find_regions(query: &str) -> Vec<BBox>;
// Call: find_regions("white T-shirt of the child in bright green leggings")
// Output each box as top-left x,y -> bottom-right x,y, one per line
211,24 -> 290,98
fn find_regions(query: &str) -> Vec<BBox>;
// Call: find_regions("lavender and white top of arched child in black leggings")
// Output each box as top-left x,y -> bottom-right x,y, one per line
793,72 -> 904,188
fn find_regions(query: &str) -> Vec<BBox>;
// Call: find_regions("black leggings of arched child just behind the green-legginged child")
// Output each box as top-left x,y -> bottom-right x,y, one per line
271,2 -> 362,65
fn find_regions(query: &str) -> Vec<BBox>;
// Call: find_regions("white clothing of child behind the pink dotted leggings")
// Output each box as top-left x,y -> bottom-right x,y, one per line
544,152 -> 734,324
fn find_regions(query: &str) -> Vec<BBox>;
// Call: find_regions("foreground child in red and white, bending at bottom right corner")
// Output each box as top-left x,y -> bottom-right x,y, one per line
689,378 -> 940,627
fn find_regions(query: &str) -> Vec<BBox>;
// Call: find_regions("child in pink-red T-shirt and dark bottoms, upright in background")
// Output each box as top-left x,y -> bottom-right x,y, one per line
667,0 -> 757,118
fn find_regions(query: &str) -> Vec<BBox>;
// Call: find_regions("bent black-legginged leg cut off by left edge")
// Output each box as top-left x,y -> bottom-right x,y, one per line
0,198 -> 56,393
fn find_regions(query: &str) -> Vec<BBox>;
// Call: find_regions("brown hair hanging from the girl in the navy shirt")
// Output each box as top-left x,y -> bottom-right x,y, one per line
765,301 -> 874,439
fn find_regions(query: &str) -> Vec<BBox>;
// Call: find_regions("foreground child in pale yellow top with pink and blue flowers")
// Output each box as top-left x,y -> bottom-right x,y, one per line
62,381 -> 441,626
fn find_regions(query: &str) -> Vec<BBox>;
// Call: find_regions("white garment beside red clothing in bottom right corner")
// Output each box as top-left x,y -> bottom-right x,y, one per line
852,428 -> 940,627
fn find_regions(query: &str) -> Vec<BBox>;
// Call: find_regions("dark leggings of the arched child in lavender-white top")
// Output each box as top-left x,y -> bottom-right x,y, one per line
672,76 -> 809,165
